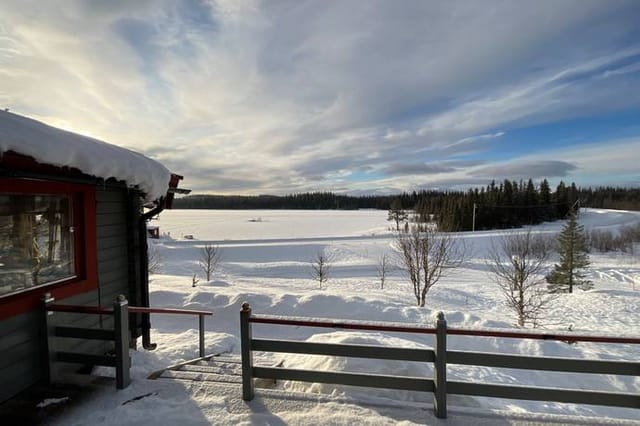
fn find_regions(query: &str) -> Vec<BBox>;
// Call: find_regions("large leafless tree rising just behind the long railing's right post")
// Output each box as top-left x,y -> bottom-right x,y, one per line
396,224 -> 465,307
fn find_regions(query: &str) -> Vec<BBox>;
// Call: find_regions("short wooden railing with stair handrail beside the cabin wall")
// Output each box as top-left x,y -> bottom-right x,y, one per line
43,294 -> 213,389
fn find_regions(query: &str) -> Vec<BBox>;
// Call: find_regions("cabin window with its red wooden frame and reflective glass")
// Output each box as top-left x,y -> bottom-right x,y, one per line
0,178 -> 97,317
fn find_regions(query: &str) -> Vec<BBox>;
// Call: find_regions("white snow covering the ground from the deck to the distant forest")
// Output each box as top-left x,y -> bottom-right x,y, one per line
55,209 -> 640,424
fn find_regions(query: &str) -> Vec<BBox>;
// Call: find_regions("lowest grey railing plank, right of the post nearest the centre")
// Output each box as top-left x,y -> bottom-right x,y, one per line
447,382 -> 640,408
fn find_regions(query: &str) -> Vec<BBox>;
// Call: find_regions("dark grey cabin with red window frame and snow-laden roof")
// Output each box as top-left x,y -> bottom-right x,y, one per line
0,111 -> 182,402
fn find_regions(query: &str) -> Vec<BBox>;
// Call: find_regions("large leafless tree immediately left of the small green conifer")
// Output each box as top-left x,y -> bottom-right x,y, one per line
487,230 -> 554,327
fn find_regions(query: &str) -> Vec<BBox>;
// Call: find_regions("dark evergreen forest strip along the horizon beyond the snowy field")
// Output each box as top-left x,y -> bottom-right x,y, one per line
174,179 -> 640,230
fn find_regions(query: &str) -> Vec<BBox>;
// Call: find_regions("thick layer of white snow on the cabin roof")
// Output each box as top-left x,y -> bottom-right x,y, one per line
0,111 -> 171,201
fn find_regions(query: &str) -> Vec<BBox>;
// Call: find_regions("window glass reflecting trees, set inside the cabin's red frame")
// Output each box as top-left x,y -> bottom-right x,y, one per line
0,194 -> 75,296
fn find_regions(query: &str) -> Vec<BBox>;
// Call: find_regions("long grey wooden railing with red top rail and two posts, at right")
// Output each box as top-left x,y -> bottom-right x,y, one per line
240,303 -> 640,418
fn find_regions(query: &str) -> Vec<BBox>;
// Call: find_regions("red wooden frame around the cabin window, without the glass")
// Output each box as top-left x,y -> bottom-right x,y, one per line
0,178 -> 98,320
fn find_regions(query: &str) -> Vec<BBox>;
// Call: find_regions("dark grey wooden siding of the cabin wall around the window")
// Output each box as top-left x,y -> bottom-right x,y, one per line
0,188 -> 139,402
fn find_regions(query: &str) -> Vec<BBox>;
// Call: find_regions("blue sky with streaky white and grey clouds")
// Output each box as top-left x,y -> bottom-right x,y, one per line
0,0 -> 640,194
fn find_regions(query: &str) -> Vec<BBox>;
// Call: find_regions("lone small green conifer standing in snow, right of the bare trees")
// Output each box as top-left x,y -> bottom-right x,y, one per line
547,213 -> 593,293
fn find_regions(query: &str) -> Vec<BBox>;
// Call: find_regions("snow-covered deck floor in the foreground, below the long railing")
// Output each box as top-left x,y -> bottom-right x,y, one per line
46,372 -> 638,426
